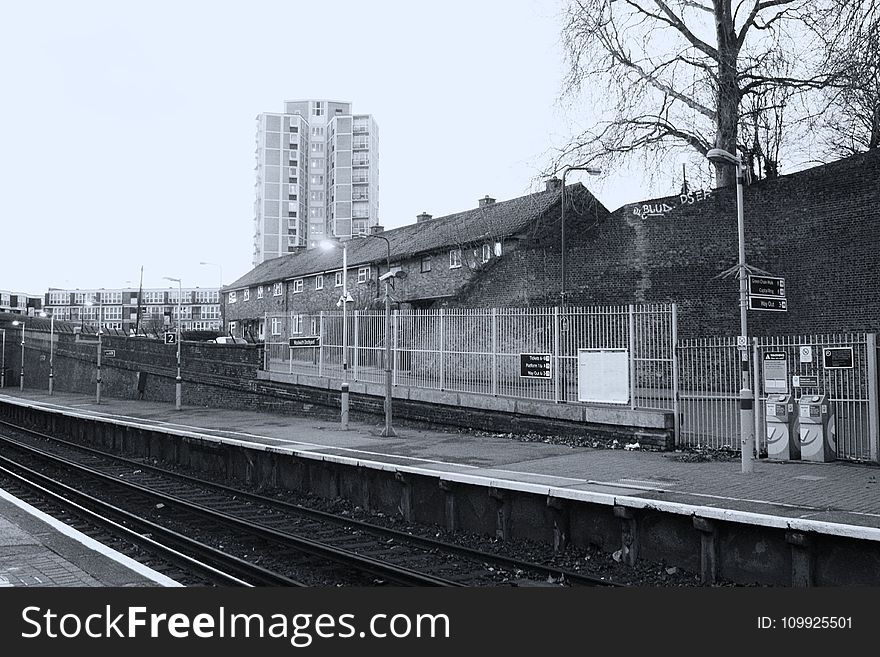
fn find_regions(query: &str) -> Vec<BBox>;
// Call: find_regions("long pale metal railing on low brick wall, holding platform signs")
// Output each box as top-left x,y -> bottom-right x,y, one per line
265,305 -> 676,410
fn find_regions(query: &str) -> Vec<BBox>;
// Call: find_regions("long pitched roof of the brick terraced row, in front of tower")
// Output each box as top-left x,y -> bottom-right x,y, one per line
223,183 -> 583,290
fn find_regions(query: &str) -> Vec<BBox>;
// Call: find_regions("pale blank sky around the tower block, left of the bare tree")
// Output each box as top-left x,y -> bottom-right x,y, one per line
0,0 -> 646,294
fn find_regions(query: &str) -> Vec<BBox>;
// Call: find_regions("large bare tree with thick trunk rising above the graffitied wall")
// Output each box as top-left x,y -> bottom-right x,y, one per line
557,0 -> 852,185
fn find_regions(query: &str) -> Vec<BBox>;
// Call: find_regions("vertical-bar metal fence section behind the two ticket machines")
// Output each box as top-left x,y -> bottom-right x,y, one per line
677,334 -> 878,461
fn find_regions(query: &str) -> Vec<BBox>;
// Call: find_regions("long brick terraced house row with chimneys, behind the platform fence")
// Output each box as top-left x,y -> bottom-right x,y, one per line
222,180 -> 608,339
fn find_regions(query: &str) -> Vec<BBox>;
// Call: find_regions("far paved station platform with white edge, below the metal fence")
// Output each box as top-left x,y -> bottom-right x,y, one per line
0,388 -> 880,582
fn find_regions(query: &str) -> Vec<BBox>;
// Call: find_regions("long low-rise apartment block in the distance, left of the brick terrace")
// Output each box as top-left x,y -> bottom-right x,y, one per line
45,287 -> 222,334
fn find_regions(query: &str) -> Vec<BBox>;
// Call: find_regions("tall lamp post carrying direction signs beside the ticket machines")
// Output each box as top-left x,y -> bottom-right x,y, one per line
706,148 -> 755,472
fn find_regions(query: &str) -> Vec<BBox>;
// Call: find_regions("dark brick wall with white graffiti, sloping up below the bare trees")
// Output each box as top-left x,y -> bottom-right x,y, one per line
456,148 -> 880,336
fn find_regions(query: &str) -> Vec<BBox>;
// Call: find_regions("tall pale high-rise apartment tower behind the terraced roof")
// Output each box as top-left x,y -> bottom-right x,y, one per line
253,100 -> 379,265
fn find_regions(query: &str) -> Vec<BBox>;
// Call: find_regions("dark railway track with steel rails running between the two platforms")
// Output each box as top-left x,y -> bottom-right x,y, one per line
2,423 -> 624,586
